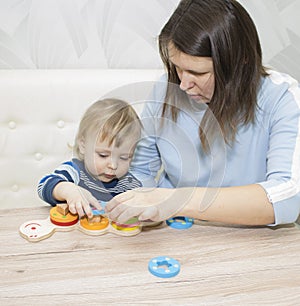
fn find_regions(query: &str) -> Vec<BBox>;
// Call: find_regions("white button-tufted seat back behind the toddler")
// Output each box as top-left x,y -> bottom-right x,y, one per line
0,69 -> 163,209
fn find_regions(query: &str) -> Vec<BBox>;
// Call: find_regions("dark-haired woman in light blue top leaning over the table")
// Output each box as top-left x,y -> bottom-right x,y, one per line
107,0 -> 300,225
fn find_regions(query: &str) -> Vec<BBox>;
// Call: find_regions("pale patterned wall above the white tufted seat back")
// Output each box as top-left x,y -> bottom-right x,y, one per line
0,0 -> 300,80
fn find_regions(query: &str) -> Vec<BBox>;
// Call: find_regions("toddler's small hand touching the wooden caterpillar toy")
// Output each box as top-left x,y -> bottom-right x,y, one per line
53,182 -> 103,218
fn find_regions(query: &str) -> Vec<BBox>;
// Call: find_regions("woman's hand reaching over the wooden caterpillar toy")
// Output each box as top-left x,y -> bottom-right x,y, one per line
105,188 -> 190,223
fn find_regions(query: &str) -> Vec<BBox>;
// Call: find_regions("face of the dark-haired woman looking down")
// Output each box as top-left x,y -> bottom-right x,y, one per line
168,44 -> 215,103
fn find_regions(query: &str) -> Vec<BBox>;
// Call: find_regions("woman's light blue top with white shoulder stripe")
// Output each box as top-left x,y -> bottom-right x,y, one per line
131,71 -> 300,225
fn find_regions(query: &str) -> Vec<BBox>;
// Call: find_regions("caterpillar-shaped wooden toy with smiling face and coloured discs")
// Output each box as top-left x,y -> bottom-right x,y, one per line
19,206 -> 142,242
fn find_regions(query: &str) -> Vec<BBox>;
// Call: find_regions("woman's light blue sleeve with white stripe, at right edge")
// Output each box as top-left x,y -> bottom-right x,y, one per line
259,74 -> 300,225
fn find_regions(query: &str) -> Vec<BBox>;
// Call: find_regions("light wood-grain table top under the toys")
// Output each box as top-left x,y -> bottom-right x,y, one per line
0,207 -> 300,306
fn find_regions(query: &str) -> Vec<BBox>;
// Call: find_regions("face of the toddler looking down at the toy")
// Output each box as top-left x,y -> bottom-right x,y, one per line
79,136 -> 137,183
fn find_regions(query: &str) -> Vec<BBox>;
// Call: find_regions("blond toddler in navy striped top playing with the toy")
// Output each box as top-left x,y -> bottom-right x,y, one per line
38,99 -> 142,218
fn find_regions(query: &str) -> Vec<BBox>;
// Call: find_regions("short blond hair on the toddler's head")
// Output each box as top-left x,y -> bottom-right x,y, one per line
73,98 -> 142,160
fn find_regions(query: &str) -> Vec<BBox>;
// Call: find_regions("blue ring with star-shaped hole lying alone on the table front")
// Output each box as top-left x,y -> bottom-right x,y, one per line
148,256 -> 180,278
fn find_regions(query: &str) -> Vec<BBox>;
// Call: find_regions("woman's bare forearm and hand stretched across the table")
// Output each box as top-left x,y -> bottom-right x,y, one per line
106,184 -> 274,225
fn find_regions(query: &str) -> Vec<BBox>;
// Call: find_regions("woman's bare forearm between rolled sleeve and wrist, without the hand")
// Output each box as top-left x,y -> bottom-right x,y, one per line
177,184 -> 275,225
